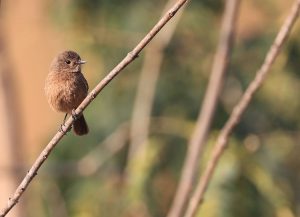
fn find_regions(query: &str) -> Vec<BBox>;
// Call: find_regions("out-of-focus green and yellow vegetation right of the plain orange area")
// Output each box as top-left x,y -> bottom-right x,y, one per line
28,0 -> 300,217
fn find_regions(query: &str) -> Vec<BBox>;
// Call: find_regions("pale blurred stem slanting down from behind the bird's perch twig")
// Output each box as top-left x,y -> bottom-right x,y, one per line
127,0 -> 183,171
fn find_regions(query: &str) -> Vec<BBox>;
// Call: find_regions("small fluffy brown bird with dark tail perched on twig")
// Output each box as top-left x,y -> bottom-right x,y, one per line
45,51 -> 89,136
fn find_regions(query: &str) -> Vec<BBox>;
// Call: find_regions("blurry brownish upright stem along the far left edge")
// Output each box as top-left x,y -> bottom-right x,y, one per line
0,29 -> 23,216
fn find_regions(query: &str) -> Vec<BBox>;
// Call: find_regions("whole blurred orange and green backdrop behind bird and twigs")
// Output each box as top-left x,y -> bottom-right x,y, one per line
0,0 -> 300,217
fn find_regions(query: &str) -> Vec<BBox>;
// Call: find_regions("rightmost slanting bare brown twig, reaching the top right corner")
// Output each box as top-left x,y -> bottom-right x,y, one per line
185,0 -> 300,217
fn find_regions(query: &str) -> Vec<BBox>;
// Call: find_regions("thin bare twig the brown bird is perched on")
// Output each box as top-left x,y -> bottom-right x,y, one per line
0,0 -> 188,217
